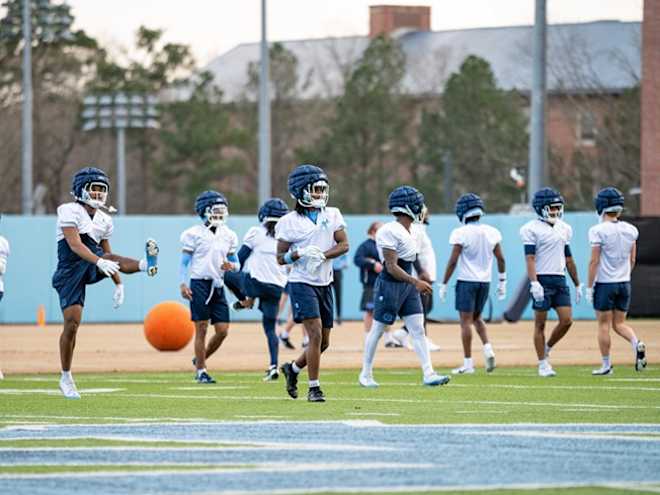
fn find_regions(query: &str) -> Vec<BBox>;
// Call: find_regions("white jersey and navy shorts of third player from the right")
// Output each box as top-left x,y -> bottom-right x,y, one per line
449,222 -> 502,314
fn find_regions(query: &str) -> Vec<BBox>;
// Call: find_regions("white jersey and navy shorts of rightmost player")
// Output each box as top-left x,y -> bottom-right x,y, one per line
589,220 -> 639,311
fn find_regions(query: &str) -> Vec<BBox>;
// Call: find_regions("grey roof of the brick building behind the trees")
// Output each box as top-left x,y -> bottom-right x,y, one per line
206,21 -> 641,101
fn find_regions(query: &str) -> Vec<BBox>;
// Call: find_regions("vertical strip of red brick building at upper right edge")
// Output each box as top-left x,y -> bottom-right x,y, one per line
640,0 -> 660,216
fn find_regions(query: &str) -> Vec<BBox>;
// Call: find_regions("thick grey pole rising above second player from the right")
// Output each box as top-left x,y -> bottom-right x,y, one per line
527,0 -> 547,201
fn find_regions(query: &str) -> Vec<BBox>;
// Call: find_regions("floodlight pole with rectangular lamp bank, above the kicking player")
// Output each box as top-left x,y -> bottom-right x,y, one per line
82,93 -> 159,215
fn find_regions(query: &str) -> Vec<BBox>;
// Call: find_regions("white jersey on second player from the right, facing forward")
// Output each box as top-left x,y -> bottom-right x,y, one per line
520,218 -> 573,275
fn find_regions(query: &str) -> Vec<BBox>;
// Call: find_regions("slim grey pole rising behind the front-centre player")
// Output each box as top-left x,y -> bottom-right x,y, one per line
259,0 -> 271,204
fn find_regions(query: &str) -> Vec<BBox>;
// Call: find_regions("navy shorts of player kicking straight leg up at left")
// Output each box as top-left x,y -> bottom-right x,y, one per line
53,252 -> 107,310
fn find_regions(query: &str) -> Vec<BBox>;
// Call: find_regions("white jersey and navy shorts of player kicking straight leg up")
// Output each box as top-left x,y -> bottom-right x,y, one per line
52,202 -> 114,310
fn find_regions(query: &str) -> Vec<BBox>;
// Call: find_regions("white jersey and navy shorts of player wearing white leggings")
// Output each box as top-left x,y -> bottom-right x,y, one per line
374,221 -> 424,325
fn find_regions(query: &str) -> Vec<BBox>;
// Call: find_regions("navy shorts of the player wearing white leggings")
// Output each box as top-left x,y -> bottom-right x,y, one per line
374,276 -> 424,325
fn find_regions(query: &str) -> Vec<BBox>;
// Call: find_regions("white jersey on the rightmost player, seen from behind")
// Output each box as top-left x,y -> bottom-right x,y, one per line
589,220 -> 639,283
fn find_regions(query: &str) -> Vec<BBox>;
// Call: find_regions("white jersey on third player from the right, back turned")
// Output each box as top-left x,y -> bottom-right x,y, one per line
449,222 -> 502,282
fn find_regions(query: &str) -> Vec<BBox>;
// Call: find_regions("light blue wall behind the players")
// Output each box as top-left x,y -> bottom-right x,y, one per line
0,213 -> 598,323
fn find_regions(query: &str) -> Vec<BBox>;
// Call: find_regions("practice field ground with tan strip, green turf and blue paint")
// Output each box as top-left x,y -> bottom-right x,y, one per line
0,321 -> 660,495
